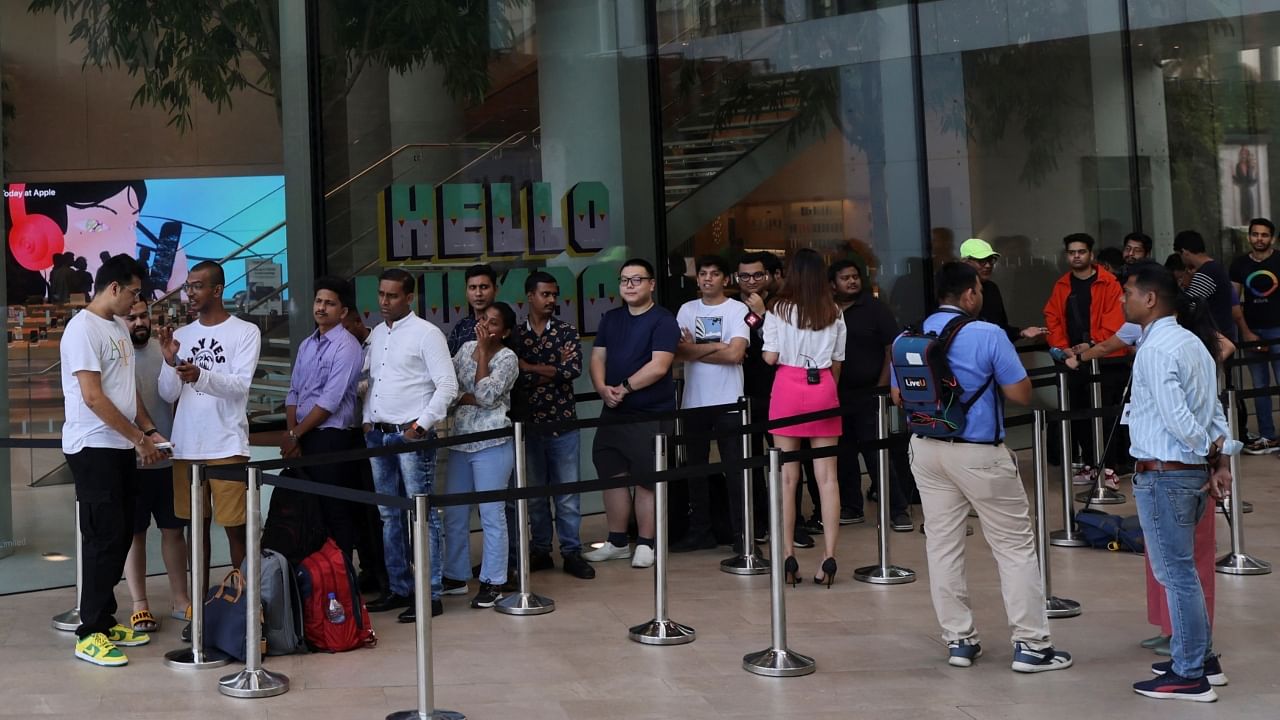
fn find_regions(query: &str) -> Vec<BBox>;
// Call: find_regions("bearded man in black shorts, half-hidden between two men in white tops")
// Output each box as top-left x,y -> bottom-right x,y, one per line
124,294 -> 191,633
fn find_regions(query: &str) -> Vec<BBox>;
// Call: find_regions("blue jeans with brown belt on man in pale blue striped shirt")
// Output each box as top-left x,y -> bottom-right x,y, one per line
1133,470 -> 1213,679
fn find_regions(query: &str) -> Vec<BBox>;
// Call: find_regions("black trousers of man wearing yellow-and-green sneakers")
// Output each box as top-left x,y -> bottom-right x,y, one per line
67,447 -> 140,638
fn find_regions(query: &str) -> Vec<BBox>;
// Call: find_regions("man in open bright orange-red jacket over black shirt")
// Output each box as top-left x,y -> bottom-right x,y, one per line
1044,233 -> 1125,488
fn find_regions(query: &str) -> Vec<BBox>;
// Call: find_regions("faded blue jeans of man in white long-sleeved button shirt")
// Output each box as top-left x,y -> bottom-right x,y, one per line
365,428 -> 443,600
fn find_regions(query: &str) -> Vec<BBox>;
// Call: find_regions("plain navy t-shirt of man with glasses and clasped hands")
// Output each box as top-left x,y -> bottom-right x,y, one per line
594,304 -> 680,413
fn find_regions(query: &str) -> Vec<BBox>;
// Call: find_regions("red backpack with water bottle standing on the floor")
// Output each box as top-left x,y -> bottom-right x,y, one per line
298,538 -> 378,652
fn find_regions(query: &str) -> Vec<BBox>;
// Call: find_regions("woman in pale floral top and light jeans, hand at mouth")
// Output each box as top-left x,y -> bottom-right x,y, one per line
444,302 -> 520,607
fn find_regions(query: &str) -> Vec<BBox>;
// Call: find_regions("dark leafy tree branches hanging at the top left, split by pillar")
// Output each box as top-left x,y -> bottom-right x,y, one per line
28,0 -> 489,131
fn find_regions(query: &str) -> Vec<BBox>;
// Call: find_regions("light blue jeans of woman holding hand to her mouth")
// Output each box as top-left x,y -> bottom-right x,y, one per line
444,439 -> 516,585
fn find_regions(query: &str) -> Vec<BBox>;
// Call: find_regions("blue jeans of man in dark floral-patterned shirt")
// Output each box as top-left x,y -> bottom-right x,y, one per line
525,430 -> 582,556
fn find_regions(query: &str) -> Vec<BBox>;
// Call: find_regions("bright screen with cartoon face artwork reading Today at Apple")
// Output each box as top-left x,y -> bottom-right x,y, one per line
4,176 -> 285,305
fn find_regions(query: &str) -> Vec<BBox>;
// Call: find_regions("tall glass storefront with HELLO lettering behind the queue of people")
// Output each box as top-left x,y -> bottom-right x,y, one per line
0,0 -> 1280,593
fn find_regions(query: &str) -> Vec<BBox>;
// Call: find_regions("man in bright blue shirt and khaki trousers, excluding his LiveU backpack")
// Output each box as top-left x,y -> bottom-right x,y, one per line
891,263 -> 1071,673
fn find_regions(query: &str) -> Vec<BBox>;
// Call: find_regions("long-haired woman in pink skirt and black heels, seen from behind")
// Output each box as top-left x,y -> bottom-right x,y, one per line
764,249 -> 845,588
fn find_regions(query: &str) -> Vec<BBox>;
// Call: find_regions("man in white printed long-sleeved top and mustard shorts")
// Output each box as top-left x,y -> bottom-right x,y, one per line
159,260 -> 261,592
